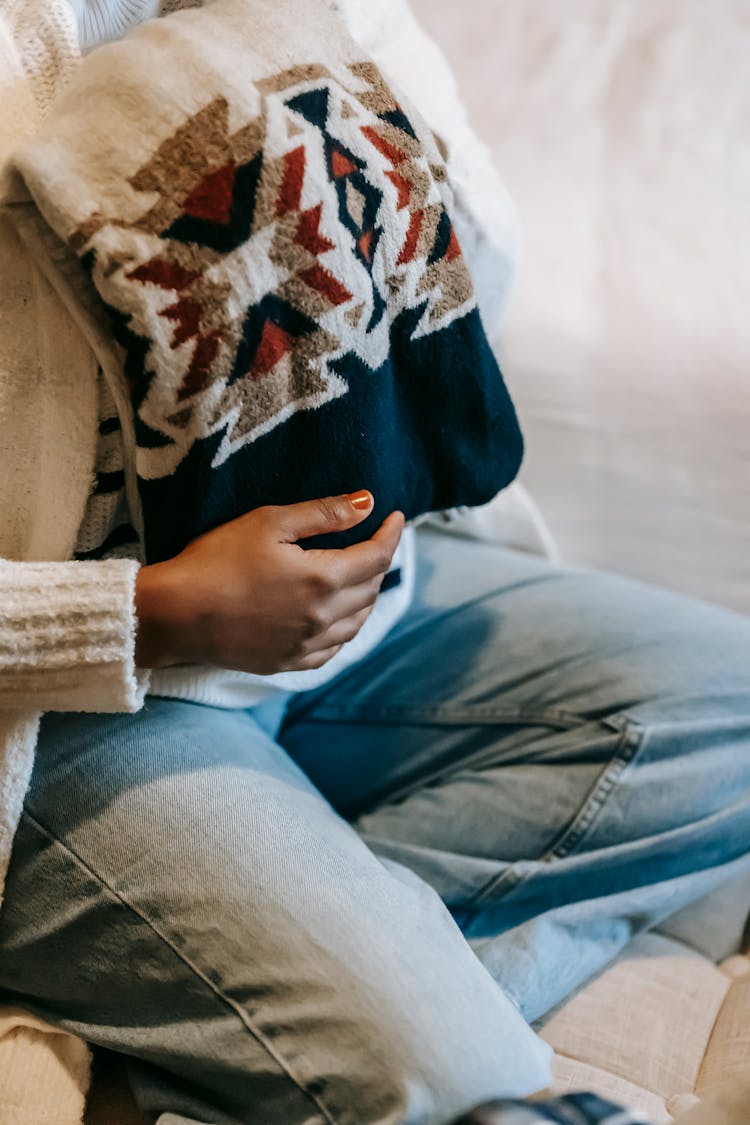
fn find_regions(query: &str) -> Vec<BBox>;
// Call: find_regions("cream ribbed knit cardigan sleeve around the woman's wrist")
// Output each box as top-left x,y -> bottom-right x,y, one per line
0,559 -> 148,712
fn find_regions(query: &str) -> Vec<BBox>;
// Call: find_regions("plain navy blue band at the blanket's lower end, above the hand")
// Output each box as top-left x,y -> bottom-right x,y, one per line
138,309 -> 523,563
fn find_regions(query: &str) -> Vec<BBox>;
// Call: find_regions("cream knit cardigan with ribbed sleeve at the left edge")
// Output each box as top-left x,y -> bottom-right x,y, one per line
0,0 -> 147,904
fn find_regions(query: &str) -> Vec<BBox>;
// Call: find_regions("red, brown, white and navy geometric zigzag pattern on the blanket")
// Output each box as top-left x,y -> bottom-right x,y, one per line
73,62 -> 475,479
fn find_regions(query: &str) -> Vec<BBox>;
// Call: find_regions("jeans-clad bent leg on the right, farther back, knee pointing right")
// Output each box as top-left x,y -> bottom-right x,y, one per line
280,532 -> 750,1018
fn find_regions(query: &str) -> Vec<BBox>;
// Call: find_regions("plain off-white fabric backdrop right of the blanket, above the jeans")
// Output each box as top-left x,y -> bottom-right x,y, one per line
414,0 -> 750,612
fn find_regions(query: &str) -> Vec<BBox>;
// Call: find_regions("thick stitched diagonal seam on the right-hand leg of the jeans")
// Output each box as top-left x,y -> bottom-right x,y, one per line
466,720 -> 645,909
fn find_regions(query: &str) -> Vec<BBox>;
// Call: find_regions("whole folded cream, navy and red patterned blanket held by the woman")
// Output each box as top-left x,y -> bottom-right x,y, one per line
4,0 -> 522,561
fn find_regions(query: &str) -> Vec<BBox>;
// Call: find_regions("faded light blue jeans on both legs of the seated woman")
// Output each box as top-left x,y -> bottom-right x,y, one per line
0,531 -> 750,1125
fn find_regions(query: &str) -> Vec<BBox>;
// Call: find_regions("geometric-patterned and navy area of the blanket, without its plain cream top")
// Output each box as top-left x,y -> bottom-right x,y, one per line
64,51 -> 522,561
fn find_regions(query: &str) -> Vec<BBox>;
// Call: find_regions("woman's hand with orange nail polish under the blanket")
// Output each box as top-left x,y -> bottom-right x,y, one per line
136,492 -> 404,675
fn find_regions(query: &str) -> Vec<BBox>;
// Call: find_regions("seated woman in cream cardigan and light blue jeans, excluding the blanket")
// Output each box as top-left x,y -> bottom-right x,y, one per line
0,5 -> 750,1125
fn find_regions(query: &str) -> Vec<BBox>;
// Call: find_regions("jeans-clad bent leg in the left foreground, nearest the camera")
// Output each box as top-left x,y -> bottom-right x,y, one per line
0,700 -> 548,1125
